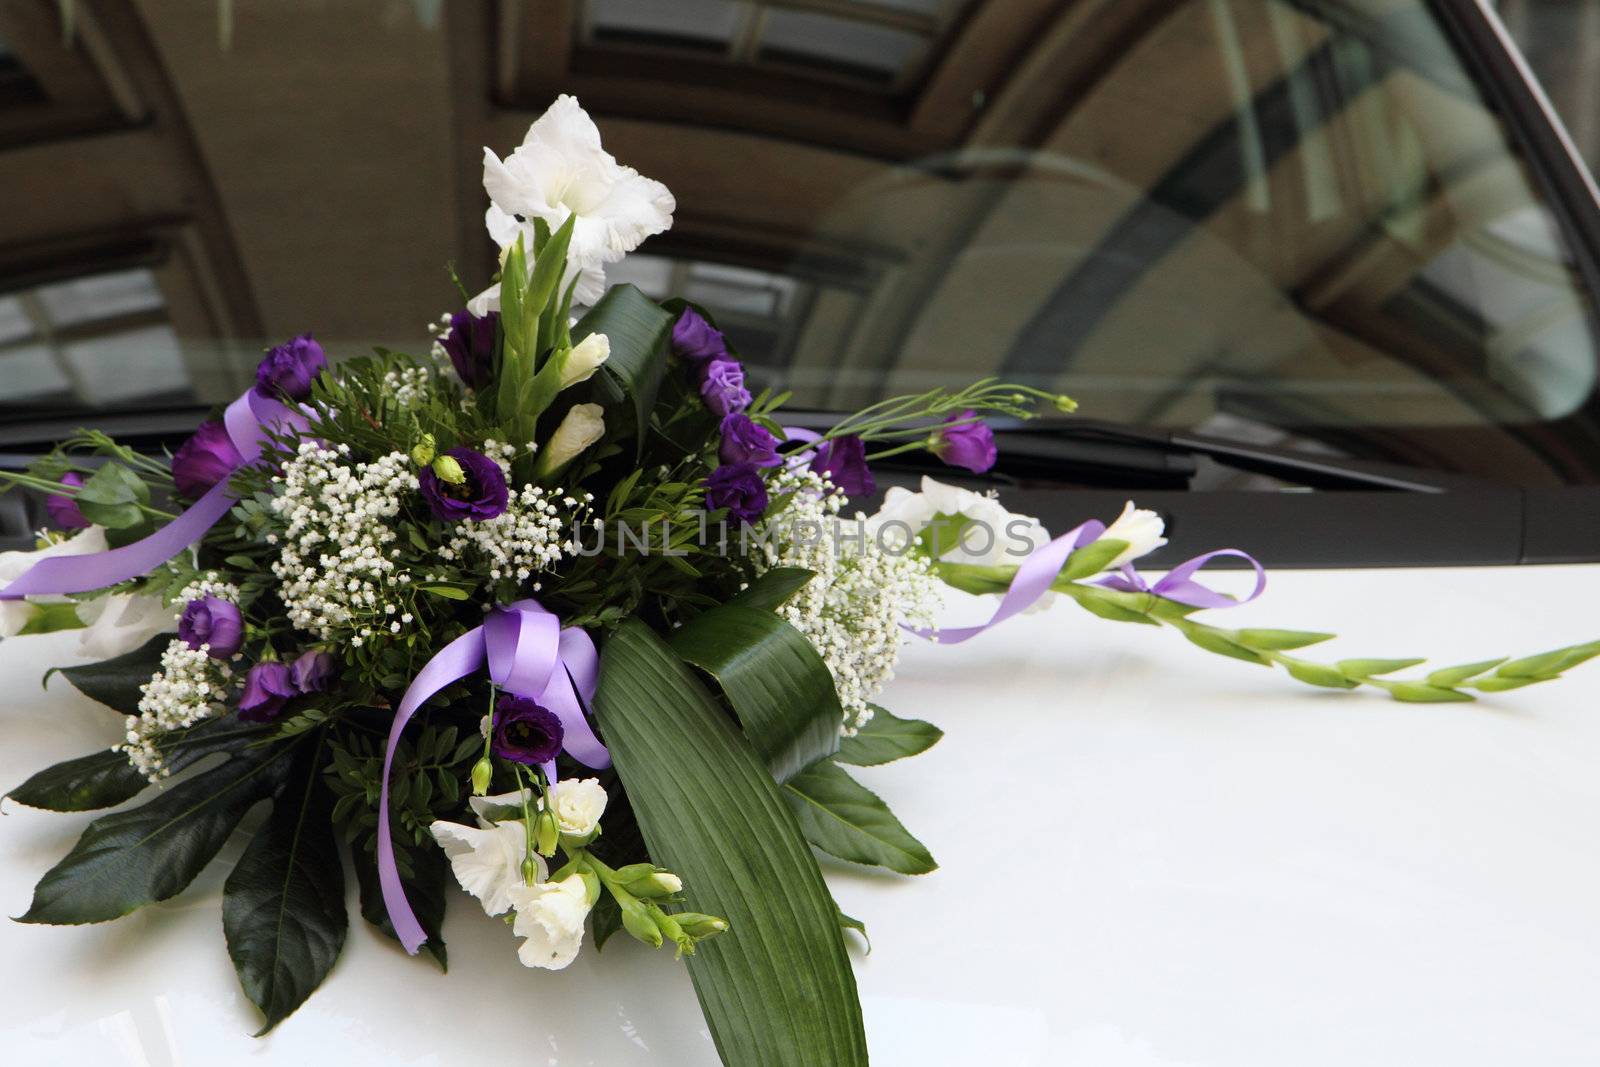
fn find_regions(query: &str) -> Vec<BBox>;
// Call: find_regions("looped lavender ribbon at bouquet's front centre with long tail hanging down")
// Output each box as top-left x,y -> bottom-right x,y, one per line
378,600 -> 611,955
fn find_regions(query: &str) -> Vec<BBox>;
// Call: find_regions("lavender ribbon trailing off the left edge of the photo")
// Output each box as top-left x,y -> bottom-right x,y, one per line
0,390 -> 310,600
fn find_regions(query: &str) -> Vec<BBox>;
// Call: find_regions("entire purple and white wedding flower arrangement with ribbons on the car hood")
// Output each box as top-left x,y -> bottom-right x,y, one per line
0,98 -> 1600,1064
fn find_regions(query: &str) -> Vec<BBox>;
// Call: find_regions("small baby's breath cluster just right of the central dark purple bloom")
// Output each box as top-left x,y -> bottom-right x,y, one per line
438,483 -> 594,592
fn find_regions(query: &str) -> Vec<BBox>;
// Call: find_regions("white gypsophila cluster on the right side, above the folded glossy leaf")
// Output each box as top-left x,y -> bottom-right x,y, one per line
762,470 -> 941,736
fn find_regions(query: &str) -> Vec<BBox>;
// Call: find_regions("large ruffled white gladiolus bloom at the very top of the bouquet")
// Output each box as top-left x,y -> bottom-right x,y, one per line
483,96 -> 677,304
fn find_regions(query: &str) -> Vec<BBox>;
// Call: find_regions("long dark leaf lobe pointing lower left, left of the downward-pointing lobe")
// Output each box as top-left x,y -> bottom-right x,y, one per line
18,744 -> 293,925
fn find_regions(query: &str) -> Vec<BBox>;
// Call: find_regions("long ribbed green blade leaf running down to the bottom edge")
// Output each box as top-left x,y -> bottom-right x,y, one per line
594,617 -> 867,1067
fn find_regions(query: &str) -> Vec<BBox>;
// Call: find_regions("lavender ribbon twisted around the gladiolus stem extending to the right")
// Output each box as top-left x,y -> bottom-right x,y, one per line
906,518 -> 1267,645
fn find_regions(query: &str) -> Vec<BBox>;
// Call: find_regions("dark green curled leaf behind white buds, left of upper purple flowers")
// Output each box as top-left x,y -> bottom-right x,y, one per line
573,285 -> 674,456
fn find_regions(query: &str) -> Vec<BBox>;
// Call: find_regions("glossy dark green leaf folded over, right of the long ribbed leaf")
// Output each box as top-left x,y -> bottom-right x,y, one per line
669,603 -> 845,782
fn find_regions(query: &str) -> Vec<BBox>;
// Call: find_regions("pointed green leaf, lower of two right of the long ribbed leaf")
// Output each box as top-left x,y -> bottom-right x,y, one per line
784,760 -> 939,875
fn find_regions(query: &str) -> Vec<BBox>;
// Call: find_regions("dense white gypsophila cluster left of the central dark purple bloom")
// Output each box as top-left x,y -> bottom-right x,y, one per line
269,442 -> 418,646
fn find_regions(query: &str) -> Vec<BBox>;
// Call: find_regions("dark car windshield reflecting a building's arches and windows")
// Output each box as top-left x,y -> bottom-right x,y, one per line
0,0 -> 1600,485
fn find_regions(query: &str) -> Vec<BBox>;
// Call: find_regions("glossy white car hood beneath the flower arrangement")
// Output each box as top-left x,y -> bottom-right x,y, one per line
0,566 -> 1600,1067
